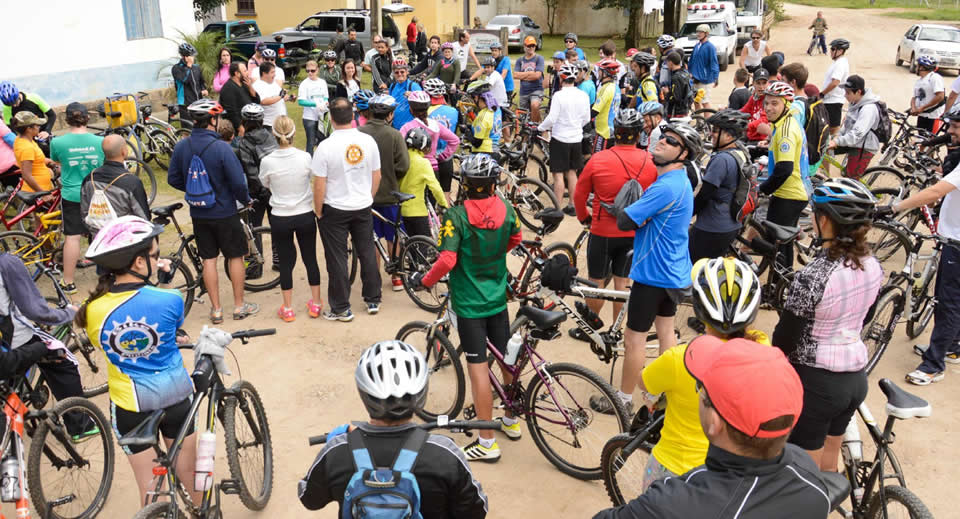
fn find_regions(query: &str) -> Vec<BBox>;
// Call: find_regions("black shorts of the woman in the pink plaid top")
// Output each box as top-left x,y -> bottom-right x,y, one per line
789,364 -> 867,451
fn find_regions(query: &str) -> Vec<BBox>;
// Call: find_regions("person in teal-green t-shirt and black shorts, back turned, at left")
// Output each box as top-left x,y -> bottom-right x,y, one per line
50,103 -> 103,294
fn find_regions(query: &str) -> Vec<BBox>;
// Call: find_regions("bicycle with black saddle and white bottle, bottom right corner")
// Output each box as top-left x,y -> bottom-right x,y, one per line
838,378 -> 933,519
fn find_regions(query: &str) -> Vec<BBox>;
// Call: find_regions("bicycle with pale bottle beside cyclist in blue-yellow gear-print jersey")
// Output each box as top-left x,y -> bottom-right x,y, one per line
118,328 -> 276,519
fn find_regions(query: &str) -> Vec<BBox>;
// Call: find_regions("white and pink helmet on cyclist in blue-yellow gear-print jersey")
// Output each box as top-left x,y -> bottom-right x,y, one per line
86,215 -> 163,270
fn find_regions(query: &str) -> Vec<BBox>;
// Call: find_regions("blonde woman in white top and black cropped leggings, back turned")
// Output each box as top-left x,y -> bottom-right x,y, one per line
260,116 -> 326,323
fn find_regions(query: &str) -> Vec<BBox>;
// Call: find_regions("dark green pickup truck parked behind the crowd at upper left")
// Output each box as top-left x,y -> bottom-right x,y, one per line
203,20 -> 314,78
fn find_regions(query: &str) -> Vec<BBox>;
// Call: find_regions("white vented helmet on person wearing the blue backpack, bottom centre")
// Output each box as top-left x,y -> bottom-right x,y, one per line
354,340 -> 427,420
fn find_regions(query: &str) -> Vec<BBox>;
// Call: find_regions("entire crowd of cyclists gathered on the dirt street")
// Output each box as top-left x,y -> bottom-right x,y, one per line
0,6 -> 948,518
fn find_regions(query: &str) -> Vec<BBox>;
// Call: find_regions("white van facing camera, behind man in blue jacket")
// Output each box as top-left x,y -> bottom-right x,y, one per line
676,2 -> 737,70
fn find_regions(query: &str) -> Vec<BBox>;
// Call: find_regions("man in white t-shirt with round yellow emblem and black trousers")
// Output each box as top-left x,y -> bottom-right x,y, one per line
310,97 -> 381,322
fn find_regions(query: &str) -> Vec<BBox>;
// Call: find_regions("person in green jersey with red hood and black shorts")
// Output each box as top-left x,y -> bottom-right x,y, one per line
410,153 -> 523,462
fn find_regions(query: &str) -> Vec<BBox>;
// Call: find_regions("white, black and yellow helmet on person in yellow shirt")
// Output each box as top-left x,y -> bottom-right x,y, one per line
690,258 -> 761,335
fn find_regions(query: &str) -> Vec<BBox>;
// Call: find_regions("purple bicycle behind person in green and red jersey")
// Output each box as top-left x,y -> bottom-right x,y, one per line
396,300 -> 629,480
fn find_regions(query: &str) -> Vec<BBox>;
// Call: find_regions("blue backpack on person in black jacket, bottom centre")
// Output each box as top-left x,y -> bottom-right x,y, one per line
340,429 -> 428,519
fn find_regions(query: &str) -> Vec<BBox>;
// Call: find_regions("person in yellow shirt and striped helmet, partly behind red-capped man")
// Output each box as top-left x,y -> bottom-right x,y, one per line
640,258 -> 770,490
